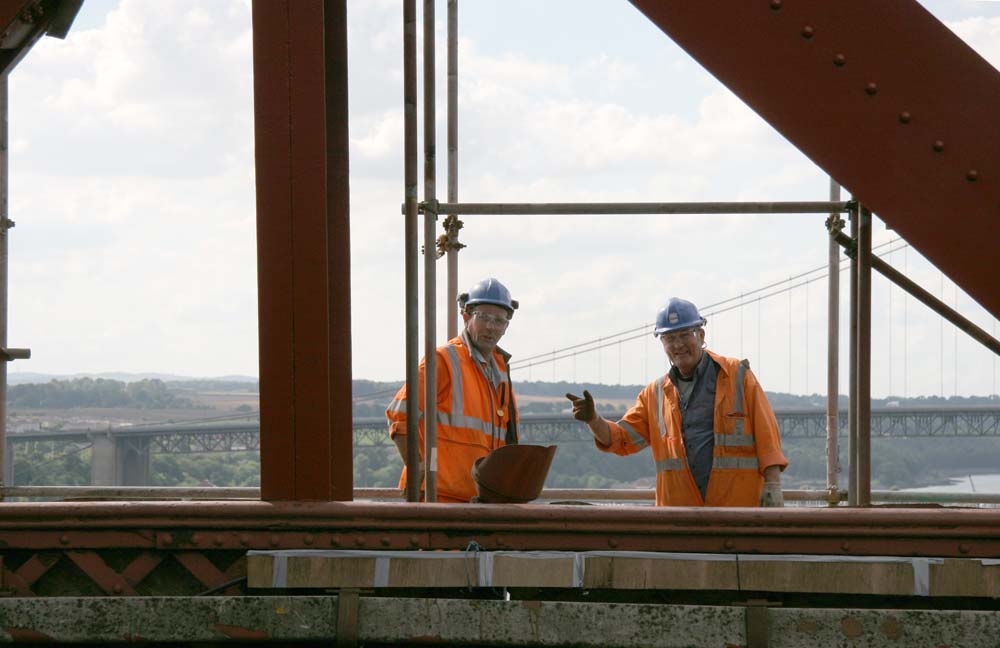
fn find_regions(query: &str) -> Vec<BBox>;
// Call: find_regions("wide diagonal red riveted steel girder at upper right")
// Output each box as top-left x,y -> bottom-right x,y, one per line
630,0 -> 1000,317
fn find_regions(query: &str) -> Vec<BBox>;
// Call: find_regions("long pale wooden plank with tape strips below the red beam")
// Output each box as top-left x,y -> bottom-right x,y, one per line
246,550 -> 1000,597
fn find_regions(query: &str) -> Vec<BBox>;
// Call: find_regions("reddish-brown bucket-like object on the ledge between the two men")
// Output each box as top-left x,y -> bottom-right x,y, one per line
472,444 -> 556,504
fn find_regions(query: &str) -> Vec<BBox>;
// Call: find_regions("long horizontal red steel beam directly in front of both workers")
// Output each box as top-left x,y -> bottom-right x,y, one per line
0,502 -> 1000,558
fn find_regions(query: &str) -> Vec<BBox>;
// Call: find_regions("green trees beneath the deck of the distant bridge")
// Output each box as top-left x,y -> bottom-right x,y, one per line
12,425 -> 1000,490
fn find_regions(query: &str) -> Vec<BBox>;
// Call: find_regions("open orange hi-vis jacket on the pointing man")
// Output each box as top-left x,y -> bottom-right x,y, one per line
595,349 -> 788,506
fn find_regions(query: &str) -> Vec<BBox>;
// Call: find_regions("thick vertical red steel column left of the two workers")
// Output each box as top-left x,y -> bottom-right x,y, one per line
253,0 -> 353,500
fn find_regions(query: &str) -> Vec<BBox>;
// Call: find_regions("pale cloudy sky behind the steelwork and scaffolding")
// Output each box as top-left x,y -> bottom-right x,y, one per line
9,0 -> 1000,396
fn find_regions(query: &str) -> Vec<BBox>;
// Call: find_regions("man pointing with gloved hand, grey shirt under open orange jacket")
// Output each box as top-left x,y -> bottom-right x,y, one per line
566,297 -> 788,506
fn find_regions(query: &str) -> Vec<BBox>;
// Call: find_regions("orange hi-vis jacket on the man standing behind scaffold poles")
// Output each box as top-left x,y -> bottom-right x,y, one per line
385,331 -> 518,502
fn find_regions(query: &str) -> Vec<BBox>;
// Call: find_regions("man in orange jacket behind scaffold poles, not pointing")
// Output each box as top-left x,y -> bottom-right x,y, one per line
386,277 -> 518,502
